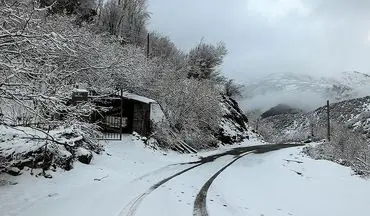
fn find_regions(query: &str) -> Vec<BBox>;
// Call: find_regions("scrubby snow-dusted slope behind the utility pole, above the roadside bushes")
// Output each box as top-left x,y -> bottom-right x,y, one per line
260,96 -> 370,142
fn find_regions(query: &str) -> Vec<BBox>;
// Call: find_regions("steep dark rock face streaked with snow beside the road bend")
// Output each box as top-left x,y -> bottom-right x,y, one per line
217,96 -> 248,144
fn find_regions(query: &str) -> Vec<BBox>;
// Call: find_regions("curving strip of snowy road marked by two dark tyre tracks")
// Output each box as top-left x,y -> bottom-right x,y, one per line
120,144 -> 296,216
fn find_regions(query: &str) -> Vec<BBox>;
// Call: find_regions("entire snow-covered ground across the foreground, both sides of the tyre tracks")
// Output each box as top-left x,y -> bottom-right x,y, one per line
0,136 -> 370,216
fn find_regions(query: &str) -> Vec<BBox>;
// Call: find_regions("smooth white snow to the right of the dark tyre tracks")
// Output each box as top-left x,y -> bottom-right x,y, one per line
208,147 -> 370,216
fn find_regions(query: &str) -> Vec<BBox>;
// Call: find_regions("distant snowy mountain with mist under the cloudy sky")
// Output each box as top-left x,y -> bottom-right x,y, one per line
244,71 -> 370,111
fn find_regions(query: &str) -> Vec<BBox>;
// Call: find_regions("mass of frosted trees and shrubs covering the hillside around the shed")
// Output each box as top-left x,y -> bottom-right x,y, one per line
0,0 -> 234,160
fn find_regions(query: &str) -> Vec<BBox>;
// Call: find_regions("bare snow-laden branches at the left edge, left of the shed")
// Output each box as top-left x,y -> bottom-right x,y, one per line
0,0 -> 108,147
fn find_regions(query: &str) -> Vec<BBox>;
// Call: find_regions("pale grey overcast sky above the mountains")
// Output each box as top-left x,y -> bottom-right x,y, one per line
149,0 -> 370,82
